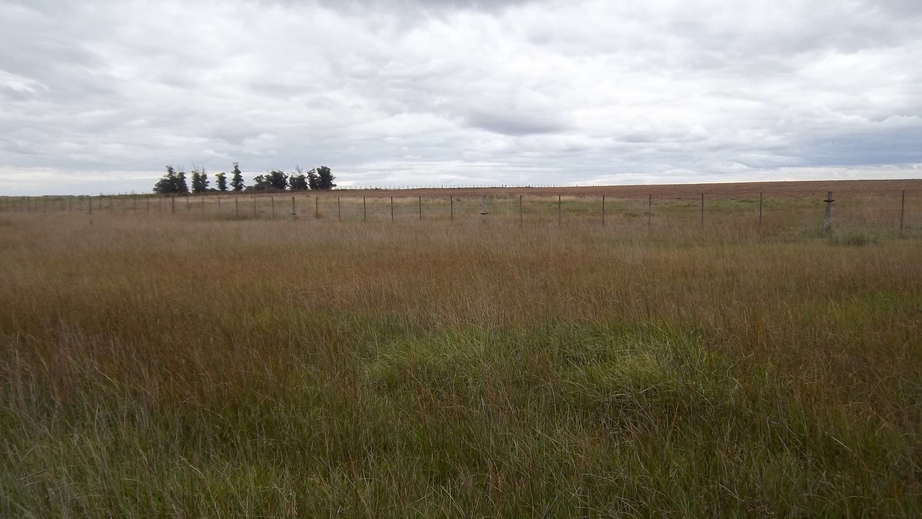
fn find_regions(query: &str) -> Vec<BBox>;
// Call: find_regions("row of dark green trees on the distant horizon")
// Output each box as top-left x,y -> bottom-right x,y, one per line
154,162 -> 336,195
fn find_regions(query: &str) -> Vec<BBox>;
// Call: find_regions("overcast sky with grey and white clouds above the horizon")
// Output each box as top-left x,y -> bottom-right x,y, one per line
0,0 -> 922,195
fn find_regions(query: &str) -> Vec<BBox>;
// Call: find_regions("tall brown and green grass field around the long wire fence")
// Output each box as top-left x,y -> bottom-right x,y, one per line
0,182 -> 922,517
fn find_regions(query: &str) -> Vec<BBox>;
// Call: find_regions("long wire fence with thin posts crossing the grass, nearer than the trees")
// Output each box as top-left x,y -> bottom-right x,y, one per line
0,190 -> 922,236
